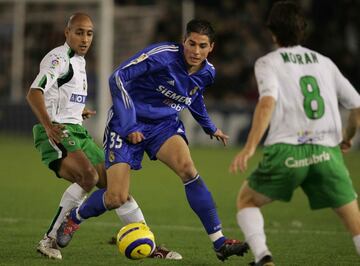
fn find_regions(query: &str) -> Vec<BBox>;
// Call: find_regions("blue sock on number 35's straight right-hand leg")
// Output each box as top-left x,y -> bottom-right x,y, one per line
185,175 -> 225,248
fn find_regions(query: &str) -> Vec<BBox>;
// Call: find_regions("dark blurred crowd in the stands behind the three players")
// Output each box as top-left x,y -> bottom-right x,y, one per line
0,0 -> 360,145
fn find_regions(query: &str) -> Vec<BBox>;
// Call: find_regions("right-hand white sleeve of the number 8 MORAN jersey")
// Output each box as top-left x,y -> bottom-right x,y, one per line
332,63 -> 360,109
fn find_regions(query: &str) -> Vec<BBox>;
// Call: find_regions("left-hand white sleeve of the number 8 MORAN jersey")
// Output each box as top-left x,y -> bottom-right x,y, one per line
255,57 -> 279,100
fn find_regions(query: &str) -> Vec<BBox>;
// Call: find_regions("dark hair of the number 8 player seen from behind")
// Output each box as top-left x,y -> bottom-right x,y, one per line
267,1 -> 306,47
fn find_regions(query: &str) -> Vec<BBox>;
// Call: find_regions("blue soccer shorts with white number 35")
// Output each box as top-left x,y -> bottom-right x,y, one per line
104,118 -> 188,170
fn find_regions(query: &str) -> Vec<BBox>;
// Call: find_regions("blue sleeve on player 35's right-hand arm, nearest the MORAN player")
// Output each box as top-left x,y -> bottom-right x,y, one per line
189,94 -> 217,135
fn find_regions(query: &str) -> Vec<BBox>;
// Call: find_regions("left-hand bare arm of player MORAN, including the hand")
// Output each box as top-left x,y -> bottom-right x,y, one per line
229,96 -> 276,173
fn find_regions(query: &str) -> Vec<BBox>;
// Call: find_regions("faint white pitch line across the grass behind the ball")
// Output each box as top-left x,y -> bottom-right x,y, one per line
0,217 -> 348,235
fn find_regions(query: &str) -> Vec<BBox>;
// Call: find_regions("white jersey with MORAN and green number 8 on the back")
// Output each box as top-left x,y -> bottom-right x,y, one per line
255,46 -> 360,146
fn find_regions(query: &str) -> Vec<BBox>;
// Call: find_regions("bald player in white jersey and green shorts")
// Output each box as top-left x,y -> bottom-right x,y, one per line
26,13 -> 181,259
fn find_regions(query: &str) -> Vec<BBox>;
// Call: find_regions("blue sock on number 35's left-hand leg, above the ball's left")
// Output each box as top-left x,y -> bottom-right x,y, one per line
70,188 -> 107,224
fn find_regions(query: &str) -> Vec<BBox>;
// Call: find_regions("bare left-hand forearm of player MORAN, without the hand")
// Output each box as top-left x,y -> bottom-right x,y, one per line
244,96 -> 276,151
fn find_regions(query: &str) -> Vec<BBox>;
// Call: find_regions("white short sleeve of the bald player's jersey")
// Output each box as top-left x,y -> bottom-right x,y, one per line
30,53 -> 69,92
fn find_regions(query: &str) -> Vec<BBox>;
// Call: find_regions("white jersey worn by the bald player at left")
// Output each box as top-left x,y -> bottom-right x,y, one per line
31,43 -> 87,124
